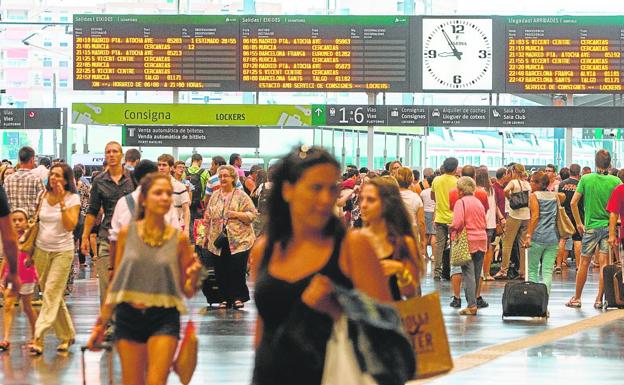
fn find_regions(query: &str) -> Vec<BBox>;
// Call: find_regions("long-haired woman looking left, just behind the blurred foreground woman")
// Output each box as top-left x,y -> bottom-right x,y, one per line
360,177 -> 424,301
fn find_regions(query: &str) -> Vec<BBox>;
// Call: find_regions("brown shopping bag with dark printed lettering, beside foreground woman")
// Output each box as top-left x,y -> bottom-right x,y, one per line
394,291 -> 453,379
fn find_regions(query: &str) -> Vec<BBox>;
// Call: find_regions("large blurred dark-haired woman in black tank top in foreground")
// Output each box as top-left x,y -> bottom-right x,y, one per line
252,146 -> 390,385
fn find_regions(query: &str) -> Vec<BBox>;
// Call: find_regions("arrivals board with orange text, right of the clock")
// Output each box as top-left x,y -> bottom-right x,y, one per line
505,16 -> 624,94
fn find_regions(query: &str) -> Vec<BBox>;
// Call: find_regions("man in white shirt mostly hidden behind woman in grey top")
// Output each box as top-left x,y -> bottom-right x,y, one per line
108,159 -> 180,250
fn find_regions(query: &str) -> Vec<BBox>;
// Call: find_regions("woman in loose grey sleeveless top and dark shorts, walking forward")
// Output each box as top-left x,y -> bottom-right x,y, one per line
87,173 -> 201,385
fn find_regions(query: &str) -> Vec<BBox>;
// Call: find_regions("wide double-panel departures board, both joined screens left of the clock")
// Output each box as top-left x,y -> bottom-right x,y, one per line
74,15 -> 415,92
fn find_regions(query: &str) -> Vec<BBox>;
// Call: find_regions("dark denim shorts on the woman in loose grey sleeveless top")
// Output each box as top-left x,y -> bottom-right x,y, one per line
115,302 -> 180,344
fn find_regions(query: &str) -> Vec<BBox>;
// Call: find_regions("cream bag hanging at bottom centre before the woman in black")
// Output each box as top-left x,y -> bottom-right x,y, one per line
321,315 -> 377,385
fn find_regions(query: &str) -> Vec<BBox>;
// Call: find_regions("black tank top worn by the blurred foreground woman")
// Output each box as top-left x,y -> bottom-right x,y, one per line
253,234 -> 353,385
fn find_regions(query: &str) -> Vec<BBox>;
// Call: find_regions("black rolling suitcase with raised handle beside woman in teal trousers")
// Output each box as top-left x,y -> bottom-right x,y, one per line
503,250 -> 548,319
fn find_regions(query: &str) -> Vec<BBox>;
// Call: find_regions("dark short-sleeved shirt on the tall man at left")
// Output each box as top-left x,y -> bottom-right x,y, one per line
87,170 -> 136,240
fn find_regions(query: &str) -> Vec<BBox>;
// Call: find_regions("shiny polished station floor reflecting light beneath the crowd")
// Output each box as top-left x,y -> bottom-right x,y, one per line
0,258 -> 624,385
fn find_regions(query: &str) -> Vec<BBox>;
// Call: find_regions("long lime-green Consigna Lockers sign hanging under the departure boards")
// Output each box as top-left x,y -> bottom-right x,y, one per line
72,103 -> 312,127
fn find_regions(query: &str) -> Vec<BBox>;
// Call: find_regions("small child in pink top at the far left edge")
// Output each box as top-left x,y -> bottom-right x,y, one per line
0,209 -> 37,351
